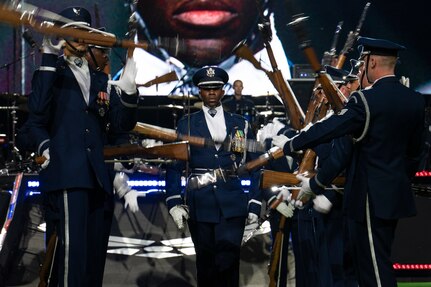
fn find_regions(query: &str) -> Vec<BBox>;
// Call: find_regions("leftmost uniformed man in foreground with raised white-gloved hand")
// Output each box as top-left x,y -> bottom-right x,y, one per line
28,7 -> 137,286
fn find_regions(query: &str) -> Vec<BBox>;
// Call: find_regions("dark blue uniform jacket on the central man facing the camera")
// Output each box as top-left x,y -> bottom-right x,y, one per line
166,110 -> 261,223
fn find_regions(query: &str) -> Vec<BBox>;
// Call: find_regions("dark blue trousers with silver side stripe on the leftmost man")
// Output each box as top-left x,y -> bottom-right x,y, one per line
45,189 -> 107,287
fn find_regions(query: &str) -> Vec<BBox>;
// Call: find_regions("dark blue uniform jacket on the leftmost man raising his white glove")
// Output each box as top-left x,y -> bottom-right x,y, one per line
29,54 -> 137,193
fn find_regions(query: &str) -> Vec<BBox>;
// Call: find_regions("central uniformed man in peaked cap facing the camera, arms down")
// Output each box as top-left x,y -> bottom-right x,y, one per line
166,67 -> 261,287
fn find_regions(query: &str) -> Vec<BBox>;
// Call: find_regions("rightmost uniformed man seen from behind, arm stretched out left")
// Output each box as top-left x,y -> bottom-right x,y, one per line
273,37 -> 425,286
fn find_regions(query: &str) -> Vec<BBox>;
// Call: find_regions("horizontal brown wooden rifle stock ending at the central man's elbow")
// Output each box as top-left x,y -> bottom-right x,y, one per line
103,142 -> 189,161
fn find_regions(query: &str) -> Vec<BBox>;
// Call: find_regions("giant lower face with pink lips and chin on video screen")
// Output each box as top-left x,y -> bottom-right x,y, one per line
138,0 -> 258,67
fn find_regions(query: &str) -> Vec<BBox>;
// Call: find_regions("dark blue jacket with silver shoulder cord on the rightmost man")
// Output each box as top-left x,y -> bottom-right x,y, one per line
284,76 -> 425,223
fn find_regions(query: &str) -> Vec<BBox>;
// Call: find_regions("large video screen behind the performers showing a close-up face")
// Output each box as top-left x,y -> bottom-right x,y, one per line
0,0 -> 431,96
